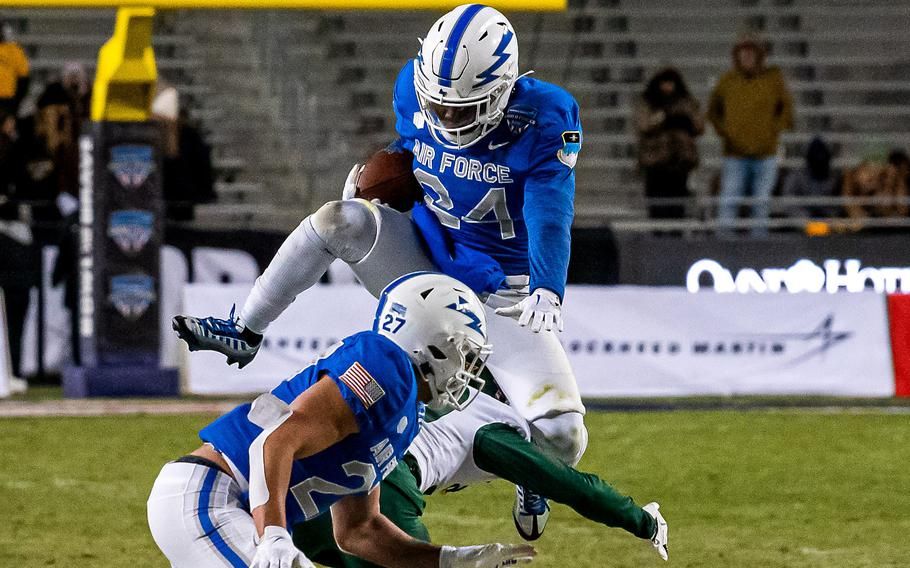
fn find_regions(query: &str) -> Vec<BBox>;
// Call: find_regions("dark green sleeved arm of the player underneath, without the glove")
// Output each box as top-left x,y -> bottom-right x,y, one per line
474,424 -> 655,539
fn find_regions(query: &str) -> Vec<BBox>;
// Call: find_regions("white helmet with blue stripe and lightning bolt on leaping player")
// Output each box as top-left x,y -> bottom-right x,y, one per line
414,4 -> 518,149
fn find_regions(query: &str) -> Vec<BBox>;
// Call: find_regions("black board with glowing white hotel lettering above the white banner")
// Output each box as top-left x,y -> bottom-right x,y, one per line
616,233 -> 910,286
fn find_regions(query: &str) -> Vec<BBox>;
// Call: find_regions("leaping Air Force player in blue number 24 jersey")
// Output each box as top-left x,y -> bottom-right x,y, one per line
175,4 -> 587,539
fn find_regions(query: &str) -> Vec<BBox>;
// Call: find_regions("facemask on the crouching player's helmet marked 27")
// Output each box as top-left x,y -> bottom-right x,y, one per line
417,333 -> 493,411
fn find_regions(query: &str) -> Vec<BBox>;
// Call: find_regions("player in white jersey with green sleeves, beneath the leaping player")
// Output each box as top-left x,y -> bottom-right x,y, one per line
294,388 -> 667,568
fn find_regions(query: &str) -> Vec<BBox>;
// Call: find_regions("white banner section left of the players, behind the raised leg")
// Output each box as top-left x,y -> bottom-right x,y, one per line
181,284 -> 376,394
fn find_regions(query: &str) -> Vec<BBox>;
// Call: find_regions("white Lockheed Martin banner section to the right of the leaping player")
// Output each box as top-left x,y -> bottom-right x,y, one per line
562,286 -> 894,397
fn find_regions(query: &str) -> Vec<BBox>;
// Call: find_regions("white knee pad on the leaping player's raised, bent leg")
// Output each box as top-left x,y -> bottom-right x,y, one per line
309,199 -> 378,263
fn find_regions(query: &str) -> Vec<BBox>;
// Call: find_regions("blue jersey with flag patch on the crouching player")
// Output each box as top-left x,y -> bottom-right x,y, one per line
199,331 -> 423,526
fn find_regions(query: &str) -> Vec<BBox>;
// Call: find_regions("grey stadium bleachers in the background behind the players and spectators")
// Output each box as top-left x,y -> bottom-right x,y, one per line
0,0 -> 910,228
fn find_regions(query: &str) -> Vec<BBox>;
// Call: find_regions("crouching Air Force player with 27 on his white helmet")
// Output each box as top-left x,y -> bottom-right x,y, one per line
156,273 -> 534,568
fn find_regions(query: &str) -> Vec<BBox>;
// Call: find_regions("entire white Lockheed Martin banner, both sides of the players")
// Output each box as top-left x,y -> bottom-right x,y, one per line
181,284 -> 894,397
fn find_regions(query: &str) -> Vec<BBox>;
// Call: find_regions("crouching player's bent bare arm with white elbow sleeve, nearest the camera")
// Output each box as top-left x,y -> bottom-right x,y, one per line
250,377 -> 359,535
